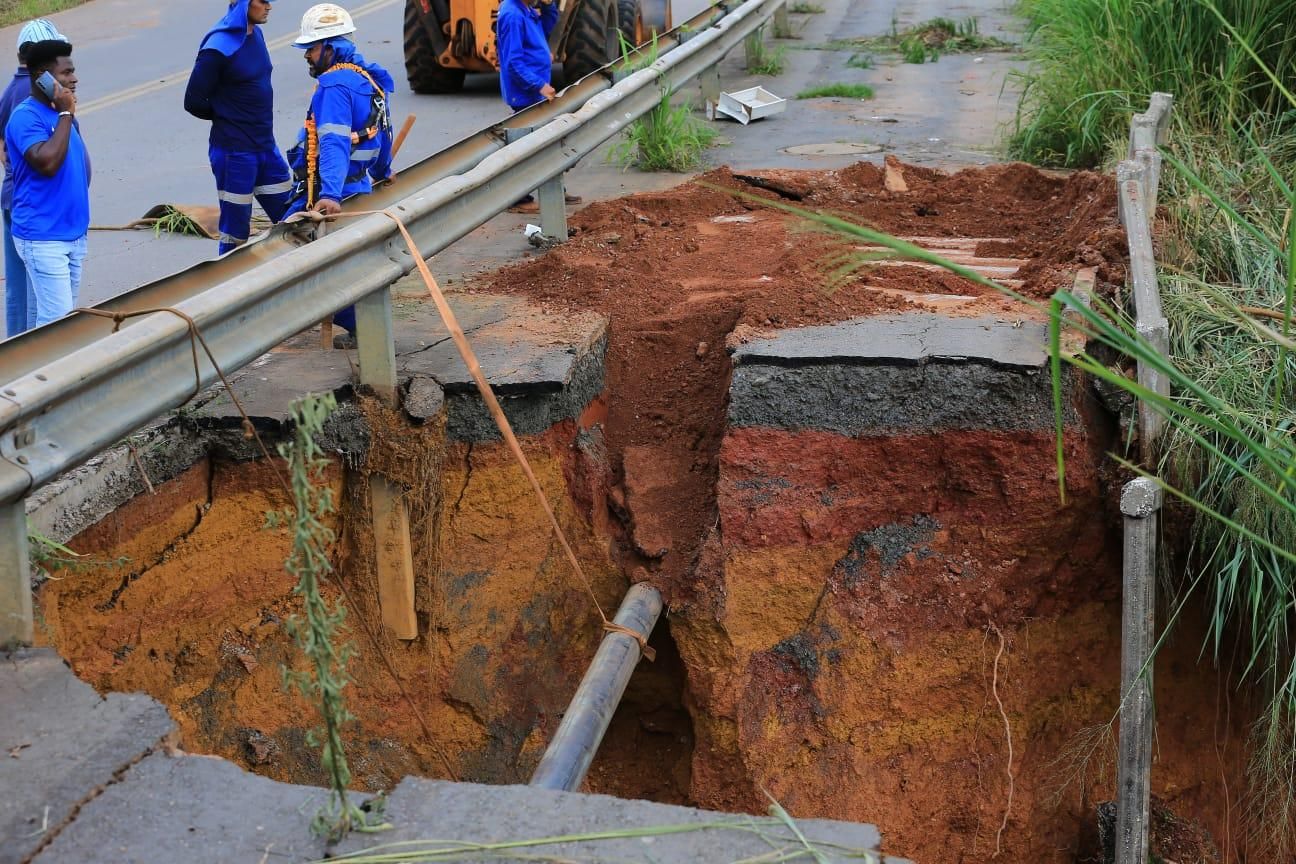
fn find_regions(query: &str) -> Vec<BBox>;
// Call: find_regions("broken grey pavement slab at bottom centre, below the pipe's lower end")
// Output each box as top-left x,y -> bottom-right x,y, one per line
338,777 -> 901,864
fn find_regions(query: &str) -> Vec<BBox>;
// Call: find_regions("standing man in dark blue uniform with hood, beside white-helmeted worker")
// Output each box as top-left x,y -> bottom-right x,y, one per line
184,0 -> 293,254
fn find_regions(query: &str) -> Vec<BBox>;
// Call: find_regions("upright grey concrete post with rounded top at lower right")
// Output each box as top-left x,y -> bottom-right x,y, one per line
1116,477 -> 1161,864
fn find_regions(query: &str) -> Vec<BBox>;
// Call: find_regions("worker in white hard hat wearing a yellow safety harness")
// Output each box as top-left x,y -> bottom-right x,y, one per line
288,3 -> 395,333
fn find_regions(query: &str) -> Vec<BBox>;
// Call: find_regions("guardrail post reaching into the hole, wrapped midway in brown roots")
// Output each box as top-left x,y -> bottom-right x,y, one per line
355,289 -> 419,639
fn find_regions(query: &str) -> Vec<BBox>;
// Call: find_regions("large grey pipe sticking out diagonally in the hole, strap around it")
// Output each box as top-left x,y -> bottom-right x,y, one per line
531,582 -> 661,791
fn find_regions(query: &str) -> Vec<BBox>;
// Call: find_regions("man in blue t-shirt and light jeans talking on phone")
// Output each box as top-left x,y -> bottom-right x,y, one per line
4,40 -> 89,326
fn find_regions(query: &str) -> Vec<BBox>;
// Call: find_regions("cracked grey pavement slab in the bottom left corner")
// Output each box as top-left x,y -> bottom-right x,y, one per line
0,649 -> 174,864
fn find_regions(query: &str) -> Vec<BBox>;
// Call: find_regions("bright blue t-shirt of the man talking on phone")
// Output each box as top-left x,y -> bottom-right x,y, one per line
4,97 -> 89,241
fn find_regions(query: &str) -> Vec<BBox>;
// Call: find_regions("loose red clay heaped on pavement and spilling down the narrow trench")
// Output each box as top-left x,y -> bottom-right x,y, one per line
490,162 -> 1124,597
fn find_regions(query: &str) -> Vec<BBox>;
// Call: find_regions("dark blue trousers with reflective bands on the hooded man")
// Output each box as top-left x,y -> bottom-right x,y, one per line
207,144 -> 293,255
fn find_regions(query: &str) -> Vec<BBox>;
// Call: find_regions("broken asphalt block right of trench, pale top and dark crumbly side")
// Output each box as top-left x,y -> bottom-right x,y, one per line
728,312 -> 1076,435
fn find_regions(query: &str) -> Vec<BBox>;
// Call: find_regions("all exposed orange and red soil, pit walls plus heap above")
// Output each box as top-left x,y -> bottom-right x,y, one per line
32,163 -> 1245,864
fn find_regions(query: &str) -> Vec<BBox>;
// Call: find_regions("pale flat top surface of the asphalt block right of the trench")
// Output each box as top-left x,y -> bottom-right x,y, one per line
734,312 -> 1048,369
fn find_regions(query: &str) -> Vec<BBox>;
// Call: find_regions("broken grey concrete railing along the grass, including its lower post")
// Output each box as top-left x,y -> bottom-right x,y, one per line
1116,93 -> 1173,864
